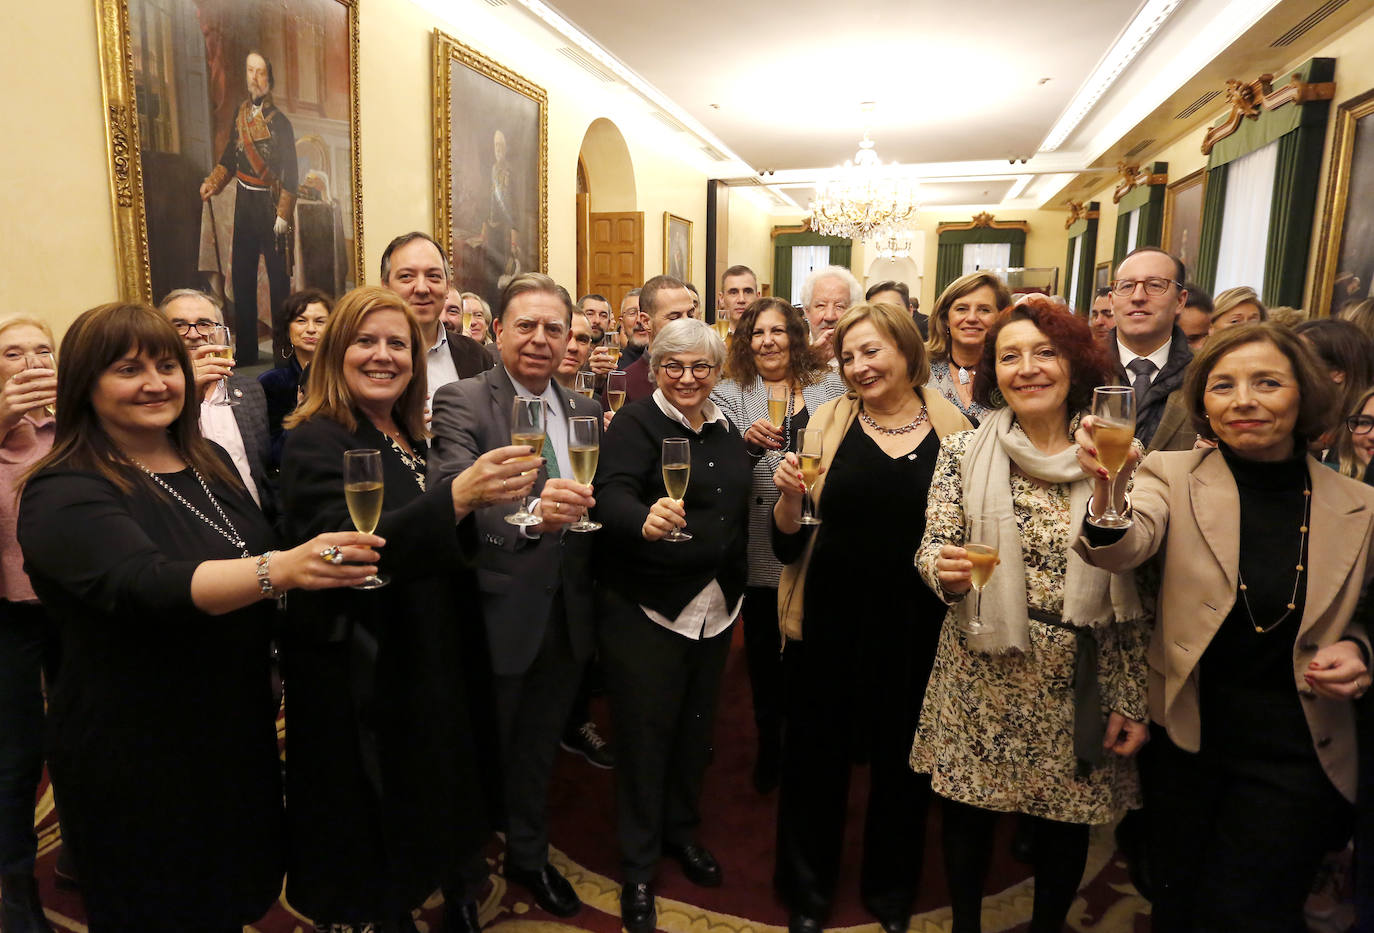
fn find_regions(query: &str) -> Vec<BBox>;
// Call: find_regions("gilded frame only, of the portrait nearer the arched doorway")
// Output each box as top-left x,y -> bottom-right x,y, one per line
434,29 -> 548,272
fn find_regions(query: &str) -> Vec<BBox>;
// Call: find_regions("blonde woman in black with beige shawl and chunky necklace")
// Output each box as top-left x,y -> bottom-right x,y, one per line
772,304 -> 969,933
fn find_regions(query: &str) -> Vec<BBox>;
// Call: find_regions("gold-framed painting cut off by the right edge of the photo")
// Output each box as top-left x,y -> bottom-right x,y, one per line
1305,89 -> 1374,317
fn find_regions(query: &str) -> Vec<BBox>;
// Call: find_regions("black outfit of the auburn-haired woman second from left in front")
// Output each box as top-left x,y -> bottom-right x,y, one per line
282,418 -> 496,923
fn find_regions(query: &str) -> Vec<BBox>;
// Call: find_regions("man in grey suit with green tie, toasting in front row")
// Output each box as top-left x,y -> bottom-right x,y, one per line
429,272 -> 602,917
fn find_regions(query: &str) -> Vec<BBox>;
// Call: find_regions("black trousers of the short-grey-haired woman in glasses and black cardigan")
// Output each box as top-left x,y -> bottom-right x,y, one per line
600,589 -> 732,885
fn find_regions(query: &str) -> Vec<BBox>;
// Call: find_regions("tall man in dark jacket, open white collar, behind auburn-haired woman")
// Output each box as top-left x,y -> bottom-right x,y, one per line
382,231 -> 496,400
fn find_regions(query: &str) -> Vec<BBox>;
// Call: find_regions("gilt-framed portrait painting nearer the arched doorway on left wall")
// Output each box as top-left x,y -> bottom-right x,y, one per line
434,30 -> 548,308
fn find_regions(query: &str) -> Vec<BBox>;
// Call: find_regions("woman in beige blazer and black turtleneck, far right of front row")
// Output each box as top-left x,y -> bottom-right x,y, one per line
1074,323 -> 1374,933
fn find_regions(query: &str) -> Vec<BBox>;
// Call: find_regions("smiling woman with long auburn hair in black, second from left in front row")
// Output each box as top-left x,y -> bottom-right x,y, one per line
282,287 -> 534,933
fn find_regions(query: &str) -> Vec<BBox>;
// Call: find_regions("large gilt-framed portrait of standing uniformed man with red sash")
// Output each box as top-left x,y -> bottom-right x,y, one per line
98,0 -> 363,366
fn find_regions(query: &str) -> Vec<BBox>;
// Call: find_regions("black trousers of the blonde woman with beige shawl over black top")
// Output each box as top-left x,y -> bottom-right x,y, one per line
774,642 -> 930,921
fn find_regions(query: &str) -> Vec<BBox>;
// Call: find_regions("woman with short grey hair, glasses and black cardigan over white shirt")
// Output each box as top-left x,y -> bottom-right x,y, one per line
592,317 -> 753,933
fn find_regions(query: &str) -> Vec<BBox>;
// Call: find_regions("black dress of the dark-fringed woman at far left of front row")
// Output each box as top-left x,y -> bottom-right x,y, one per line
19,458 -> 283,933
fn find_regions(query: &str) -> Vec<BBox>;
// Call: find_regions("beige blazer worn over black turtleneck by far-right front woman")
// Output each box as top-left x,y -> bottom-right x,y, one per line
1073,449 -> 1374,800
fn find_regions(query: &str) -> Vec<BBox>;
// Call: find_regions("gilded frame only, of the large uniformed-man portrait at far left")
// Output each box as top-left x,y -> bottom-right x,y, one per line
95,0 -> 364,304
